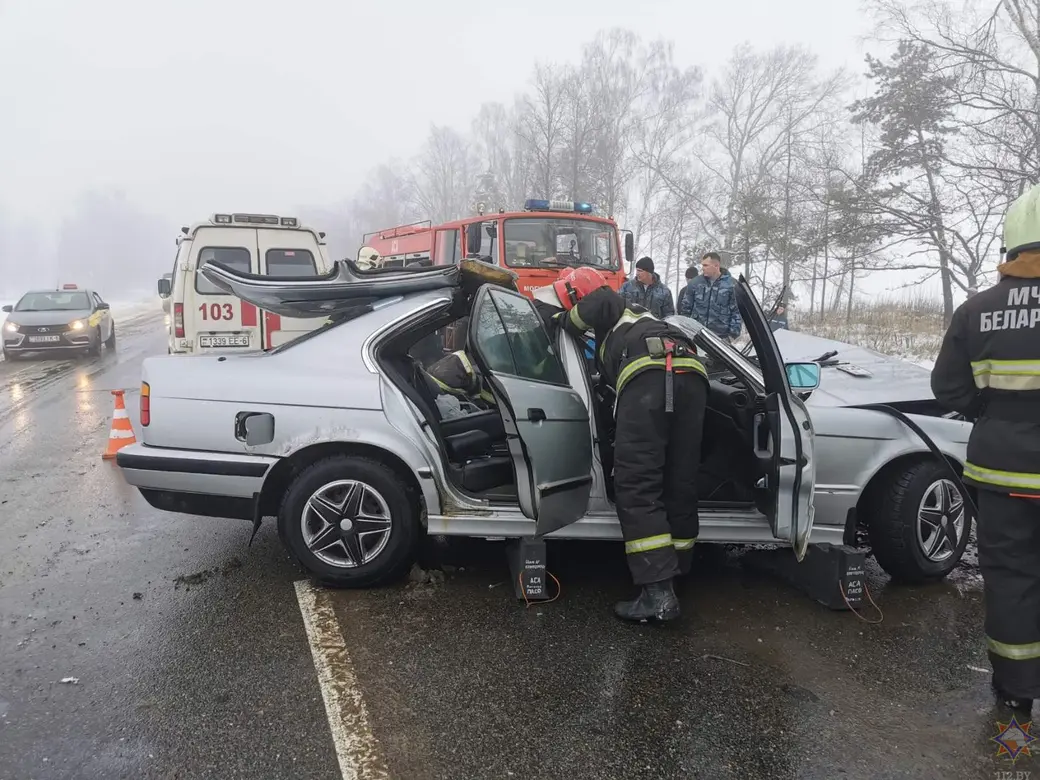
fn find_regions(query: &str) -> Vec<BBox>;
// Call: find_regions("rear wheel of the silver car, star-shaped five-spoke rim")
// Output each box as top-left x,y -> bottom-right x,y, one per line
278,456 -> 421,588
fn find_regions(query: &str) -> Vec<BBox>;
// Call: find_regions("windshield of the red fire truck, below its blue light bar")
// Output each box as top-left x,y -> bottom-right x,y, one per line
502,217 -> 619,270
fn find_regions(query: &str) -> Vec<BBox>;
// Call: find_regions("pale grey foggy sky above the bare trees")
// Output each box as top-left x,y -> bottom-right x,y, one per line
0,0 -> 866,225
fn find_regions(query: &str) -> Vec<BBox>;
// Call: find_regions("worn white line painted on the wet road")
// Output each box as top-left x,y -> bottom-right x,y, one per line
293,579 -> 390,780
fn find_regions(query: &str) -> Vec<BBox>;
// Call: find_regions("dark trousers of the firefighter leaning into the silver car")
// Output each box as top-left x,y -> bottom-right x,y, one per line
614,369 -> 707,586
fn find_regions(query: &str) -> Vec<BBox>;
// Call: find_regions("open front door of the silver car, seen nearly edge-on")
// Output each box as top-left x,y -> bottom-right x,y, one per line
736,276 -> 816,561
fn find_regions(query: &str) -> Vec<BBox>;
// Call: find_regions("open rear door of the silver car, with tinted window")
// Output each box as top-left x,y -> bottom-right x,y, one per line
467,285 -> 593,536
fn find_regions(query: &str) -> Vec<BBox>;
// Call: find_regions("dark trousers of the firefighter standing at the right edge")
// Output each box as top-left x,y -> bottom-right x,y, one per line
977,490 -> 1040,699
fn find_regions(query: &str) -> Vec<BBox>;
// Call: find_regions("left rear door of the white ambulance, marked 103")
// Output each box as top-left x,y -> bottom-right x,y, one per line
190,227 -> 261,354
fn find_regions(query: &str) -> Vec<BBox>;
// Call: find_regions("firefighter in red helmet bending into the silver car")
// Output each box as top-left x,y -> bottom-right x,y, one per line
553,268 -> 708,621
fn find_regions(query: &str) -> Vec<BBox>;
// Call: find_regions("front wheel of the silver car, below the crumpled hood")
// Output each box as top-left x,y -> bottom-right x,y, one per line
868,460 -> 972,583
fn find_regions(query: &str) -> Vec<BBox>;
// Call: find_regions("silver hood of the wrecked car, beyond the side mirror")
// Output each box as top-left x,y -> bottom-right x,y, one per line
773,330 -> 935,407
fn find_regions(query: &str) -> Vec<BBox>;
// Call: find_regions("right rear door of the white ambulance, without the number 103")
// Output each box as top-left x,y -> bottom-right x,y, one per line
257,228 -> 329,349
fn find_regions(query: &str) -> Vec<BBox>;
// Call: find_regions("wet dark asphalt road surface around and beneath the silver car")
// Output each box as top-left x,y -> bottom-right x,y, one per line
0,305 -> 1040,780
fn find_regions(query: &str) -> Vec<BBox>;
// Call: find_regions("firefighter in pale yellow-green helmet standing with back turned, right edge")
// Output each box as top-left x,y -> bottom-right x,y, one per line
932,186 -> 1040,713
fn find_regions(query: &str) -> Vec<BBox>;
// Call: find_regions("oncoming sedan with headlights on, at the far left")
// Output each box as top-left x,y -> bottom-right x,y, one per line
2,284 -> 115,360
